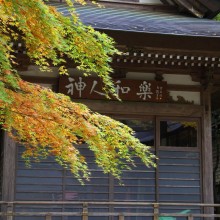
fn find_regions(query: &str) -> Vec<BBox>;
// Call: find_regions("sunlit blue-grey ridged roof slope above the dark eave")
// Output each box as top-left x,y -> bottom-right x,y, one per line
50,3 -> 220,37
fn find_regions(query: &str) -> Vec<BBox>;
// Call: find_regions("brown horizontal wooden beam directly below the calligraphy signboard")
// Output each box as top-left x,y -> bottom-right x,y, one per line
78,99 -> 203,117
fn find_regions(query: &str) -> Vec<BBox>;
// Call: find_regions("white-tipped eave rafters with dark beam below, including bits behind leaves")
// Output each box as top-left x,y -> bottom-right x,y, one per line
13,40 -> 220,85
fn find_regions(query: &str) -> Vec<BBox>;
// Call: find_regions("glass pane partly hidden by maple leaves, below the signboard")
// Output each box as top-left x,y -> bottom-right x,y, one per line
120,119 -> 155,146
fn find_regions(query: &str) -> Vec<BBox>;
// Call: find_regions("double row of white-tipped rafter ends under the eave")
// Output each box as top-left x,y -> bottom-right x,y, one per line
113,48 -> 220,70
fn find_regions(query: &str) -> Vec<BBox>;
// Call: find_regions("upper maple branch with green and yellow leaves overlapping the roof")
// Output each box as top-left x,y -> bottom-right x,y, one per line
0,0 -> 118,94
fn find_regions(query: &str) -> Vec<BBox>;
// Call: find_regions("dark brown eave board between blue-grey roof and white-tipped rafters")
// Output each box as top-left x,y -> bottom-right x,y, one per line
101,29 -> 220,54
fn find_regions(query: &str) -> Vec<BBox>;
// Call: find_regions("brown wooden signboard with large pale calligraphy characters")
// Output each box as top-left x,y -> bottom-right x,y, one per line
59,76 -> 167,102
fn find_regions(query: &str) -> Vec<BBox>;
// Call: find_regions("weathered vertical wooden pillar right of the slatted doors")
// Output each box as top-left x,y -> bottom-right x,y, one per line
201,87 -> 214,213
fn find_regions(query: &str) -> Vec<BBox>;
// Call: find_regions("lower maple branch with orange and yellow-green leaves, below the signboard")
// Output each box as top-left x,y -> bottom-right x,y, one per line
0,79 -> 154,179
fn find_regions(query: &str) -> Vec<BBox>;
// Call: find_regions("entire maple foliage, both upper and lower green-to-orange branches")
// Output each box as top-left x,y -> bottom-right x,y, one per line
0,0 -> 155,179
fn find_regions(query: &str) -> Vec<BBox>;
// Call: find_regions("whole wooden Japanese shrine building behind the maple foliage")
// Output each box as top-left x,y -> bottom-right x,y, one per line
1,0 -> 220,220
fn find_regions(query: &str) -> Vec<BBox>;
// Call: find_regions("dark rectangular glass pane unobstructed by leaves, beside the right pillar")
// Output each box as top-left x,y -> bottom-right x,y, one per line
160,120 -> 198,147
